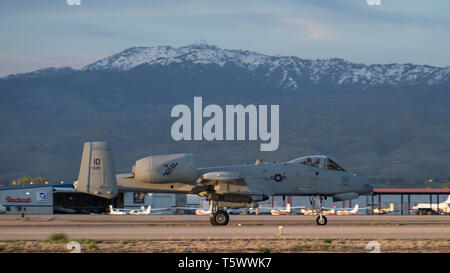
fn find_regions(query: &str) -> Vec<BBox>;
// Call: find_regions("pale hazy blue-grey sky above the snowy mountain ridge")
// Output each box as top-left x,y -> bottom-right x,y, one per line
0,0 -> 450,76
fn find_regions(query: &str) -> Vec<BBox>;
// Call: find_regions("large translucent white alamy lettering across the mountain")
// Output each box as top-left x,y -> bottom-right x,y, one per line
170,97 -> 280,151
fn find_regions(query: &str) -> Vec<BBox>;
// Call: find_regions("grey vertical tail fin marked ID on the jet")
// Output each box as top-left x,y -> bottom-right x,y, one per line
74,142 -> 118,199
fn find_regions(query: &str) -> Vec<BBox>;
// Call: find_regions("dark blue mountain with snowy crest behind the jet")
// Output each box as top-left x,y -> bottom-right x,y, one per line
0,44 -> 450,187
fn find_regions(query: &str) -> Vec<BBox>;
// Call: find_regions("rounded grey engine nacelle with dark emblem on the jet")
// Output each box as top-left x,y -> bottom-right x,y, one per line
132,154 -> 197,183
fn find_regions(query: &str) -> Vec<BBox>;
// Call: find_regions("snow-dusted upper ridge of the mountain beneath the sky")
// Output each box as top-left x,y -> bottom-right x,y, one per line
82,44 -> 450,90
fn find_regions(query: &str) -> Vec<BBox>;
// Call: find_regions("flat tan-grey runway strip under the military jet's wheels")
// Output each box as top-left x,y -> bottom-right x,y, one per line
0,215 -> 450,240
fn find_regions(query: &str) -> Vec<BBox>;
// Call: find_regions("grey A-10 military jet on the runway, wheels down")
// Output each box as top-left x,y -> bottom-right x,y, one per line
74,142 -> 372,225
